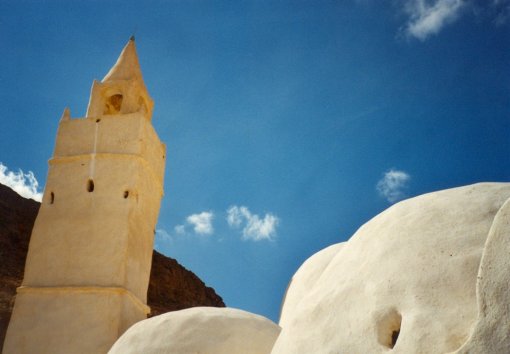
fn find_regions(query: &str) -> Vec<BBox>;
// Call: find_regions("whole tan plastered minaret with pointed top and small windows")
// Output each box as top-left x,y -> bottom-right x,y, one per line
3,38 -> 165,354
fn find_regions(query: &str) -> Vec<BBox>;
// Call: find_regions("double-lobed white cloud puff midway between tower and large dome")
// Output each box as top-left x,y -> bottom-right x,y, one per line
227,205 -> 280,241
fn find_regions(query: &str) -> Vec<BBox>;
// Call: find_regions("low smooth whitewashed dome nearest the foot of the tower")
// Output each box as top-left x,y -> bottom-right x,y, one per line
109,307 -> 280,354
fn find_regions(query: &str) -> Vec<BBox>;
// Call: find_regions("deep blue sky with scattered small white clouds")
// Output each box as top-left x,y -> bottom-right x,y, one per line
0,0 -> 510,321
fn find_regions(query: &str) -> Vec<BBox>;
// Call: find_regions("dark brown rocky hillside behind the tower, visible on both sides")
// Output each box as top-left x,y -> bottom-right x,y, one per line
0,184 -> 225,349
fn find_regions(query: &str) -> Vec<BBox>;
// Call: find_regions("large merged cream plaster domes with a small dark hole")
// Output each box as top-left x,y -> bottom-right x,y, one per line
272,183 -> 510,354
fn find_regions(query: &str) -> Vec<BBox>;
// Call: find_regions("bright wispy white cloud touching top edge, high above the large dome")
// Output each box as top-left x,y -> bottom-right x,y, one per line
405,0 -> 467,41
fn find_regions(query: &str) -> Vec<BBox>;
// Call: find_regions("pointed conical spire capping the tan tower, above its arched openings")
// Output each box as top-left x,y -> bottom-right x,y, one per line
101,36 -> 143,82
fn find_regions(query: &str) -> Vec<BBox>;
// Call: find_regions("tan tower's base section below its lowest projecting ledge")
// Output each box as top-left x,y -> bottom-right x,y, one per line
3,286 -> 149,354
